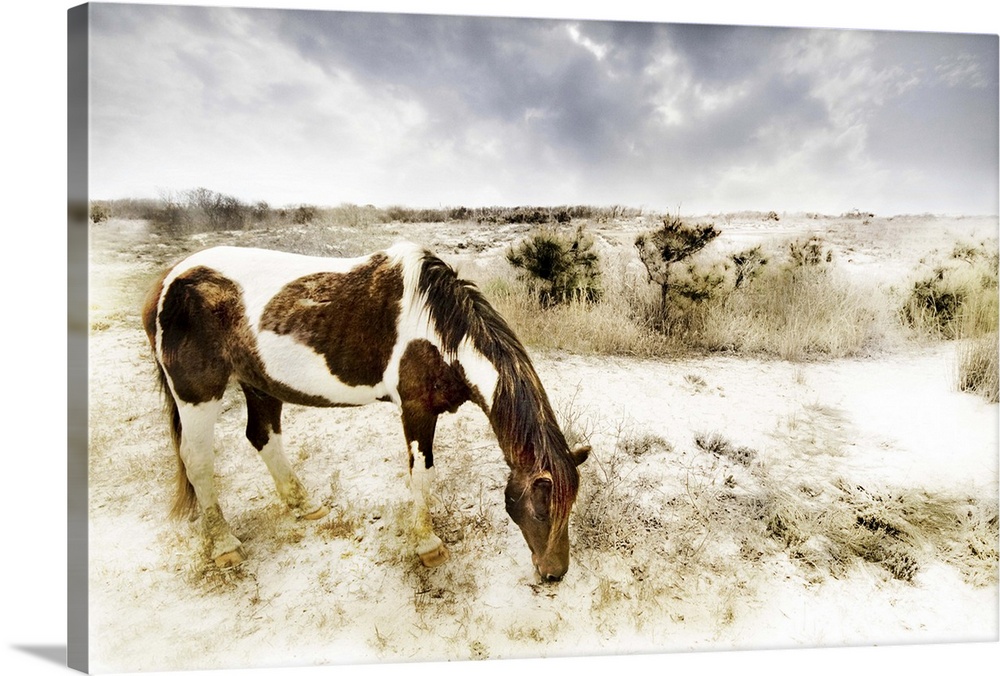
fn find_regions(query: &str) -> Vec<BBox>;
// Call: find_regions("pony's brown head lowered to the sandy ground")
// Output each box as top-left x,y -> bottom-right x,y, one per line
504,446 -> 590,581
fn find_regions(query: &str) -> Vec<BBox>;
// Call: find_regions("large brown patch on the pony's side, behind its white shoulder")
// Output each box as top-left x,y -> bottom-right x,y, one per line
260,254 -> 403,387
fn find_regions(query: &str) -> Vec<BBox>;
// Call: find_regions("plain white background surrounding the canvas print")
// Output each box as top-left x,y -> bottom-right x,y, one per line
0,0 -> 1000,676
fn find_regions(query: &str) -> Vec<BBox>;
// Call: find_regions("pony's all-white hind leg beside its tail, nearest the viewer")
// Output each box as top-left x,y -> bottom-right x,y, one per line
177,399 -> 245,568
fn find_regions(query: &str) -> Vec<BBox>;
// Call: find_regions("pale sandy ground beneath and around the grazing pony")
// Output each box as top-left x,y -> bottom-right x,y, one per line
90,215 -> 998,672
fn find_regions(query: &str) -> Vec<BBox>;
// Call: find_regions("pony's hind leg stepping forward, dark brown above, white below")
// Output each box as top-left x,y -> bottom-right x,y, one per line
241,383 -> 330,520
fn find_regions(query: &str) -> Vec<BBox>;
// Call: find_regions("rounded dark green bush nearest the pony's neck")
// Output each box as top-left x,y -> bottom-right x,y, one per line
507,226 -> 600,305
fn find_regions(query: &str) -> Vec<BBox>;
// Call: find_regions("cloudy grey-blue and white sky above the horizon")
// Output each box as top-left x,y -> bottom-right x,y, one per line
89,4 -> 1000,214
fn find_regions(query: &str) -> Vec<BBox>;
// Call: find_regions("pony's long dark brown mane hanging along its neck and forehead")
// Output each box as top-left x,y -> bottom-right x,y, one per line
419,251 -> 579,532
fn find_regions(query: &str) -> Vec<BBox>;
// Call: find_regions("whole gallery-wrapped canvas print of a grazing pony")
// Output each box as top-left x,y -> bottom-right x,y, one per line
70,3 -> 998,673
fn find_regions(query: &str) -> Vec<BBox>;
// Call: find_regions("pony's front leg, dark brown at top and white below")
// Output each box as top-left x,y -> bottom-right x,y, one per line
403,404 -> 449,567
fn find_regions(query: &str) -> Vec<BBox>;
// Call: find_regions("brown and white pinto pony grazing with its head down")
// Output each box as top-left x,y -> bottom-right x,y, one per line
143,243 -> 590,580
